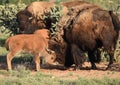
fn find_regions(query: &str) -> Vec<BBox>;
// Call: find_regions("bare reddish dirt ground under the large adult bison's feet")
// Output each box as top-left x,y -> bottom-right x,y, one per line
0,62 -> 120,80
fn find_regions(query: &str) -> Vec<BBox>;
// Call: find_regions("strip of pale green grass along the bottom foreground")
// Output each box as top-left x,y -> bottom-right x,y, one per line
0,67 -> 120,85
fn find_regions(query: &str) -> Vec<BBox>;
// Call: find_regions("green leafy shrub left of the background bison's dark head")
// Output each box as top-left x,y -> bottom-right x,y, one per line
0,4 -> 26,34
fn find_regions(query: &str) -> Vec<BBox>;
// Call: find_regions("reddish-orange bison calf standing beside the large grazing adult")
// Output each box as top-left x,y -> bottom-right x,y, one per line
6,29 -> 56,71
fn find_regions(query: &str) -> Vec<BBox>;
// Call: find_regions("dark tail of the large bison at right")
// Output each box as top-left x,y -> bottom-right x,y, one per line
109,11 -> 120,32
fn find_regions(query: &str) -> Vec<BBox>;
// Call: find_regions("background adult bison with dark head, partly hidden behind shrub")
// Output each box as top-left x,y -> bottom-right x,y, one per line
16,1 -> 55,33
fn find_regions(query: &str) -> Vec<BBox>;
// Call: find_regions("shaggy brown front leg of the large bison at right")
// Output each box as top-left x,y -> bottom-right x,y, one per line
71,44 -> 85,69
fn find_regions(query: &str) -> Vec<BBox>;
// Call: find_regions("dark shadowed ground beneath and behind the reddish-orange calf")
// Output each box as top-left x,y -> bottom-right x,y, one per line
0,55 -> 35,70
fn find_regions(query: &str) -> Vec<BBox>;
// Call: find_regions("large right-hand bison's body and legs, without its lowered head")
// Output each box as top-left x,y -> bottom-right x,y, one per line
56,1 -> 120,69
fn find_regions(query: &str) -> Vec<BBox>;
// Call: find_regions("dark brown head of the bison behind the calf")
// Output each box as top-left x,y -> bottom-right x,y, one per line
16,10 -> 45,33
